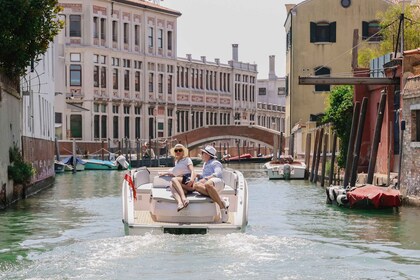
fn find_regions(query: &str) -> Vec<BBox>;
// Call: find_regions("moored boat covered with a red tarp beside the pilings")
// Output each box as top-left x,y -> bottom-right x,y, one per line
326,185 -> 402,209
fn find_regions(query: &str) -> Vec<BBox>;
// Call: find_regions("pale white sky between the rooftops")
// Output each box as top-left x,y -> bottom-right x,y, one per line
160,0 -> 303,79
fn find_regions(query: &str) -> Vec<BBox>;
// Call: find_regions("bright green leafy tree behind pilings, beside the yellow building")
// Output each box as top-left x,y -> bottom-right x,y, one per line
323,85 -> 353,167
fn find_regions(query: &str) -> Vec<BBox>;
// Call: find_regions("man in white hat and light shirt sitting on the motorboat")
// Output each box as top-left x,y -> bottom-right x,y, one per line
194,146 -> 229,223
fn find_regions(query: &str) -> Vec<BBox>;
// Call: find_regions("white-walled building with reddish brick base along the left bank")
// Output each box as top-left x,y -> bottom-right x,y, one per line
20,41 -> 57,196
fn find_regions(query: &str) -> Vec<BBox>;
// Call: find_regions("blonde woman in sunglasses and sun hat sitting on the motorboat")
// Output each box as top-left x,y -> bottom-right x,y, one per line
159,144 -> 196,211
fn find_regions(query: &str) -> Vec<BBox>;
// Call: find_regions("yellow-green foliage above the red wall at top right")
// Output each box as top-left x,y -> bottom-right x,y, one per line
358,4 -> 420,67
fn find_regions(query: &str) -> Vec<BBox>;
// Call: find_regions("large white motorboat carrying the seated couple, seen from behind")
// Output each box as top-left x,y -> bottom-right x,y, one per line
122,167 -> 248,235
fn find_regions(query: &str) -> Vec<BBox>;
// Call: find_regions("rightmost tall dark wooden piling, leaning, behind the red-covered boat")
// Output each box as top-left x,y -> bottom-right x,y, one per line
366,93 -> 386,184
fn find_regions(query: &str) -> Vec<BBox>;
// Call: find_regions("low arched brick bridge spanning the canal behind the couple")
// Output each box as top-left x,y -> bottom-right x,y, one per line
173,125 -> 284,149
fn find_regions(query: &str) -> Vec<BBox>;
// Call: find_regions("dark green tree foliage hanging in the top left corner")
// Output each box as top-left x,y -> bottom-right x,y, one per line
0,0 -> 63,79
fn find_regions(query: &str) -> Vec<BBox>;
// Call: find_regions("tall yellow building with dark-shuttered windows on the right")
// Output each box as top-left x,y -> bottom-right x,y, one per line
284,0 -> 392,135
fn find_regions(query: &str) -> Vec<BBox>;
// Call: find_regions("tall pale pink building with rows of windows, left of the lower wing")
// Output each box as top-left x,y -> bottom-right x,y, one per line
55,0 -> 181,152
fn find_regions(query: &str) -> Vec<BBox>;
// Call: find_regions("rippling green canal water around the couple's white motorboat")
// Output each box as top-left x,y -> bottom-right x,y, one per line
0,164 -> 420,280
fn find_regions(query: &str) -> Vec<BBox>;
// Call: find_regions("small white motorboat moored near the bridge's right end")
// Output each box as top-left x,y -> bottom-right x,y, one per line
264,156 -> 306,180
